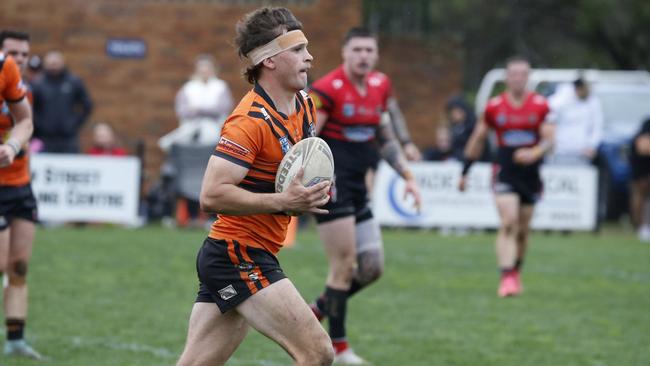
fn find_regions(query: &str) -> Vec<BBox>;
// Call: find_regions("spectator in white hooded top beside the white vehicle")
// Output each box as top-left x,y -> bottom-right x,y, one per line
549,77 -> 603,165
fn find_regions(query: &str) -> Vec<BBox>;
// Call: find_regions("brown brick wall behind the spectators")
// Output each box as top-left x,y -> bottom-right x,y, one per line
0,0 -> 459,183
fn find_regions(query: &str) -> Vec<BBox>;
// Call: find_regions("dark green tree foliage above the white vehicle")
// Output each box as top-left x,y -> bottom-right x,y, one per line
364,0 -> 650,88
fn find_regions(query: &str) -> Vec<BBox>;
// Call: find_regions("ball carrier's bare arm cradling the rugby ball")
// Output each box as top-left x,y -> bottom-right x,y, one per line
200,156 -> 330,216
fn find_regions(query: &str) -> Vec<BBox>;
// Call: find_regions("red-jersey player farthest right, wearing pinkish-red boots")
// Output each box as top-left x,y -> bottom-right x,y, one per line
459,57 -> 555,297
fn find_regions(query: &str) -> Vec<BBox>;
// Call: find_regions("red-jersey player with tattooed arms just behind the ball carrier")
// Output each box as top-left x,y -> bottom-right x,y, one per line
310,28 -> 419,364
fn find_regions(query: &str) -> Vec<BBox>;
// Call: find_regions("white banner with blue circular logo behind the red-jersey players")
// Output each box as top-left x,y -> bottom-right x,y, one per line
372,162 -> 598,231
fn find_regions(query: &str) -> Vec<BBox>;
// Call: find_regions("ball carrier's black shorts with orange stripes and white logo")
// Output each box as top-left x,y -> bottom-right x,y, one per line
196,237 -> 286,313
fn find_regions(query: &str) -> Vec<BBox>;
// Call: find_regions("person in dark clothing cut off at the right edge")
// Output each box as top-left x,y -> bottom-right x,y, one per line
630,116 -> 650,241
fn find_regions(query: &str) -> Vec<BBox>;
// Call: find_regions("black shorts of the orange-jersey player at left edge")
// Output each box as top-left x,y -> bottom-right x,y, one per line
0,184 -> 38,230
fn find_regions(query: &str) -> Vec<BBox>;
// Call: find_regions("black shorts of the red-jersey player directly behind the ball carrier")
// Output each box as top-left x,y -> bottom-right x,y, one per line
314,167 -> 372,224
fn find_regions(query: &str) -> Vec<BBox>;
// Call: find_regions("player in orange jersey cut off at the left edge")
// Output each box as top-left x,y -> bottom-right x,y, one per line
0,30 -> 41,359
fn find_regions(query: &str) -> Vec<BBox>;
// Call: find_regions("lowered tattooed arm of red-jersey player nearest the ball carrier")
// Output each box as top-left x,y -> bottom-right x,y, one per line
377,115 -> 421,210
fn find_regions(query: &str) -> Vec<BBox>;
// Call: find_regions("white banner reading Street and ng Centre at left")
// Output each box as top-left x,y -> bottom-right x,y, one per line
30,154 -> 140,225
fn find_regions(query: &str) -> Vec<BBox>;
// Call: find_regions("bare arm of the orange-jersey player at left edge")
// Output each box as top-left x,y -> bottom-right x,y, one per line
0,98 -> 34,166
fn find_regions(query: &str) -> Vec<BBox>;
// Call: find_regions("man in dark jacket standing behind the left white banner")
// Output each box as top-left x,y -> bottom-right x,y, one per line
33,51 -> 92,153
